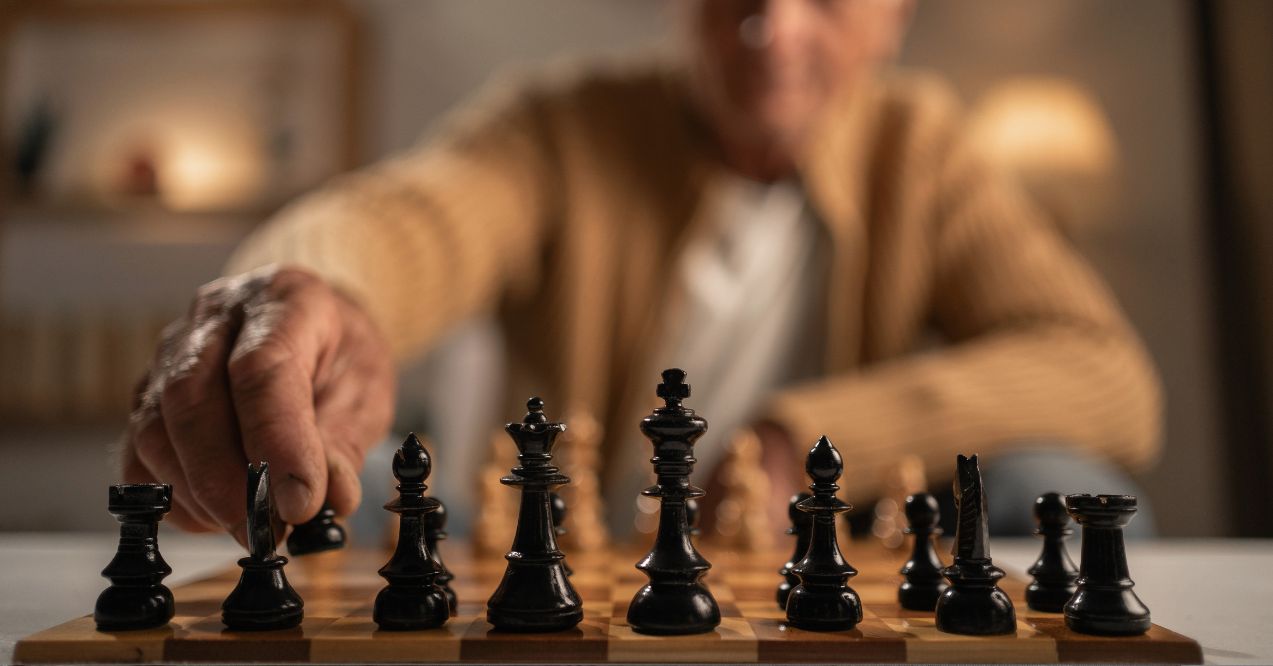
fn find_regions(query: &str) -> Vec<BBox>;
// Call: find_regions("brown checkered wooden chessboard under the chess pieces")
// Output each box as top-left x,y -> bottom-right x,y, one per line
14,544 -> 1202,663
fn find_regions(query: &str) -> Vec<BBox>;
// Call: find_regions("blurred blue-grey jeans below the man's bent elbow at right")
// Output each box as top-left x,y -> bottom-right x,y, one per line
937,446 -> 1157,539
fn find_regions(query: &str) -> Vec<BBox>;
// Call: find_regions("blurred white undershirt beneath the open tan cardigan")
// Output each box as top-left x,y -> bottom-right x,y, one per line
603,177 -> 825,536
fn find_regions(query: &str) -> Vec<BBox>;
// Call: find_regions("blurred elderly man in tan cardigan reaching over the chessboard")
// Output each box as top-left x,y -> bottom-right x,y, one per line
123,0 -> 1160,542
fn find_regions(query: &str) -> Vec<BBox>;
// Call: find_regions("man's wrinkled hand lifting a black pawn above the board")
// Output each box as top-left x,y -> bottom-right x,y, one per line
122,267 -> 395,540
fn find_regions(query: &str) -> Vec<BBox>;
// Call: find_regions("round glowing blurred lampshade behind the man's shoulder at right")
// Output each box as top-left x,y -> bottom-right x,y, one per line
969,79 -> 1118,227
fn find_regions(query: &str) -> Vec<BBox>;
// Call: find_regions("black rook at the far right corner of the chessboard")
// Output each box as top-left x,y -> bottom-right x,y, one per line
1066,495 -> 1150,635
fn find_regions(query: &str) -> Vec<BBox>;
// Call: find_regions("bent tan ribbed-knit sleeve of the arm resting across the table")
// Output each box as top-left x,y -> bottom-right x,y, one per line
770,127 -> 1161,499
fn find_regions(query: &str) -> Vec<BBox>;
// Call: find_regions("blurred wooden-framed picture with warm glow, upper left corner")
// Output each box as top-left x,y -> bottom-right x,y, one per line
0,0 -> 360,214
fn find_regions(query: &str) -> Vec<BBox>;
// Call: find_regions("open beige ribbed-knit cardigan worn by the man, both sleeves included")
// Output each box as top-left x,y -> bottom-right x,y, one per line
229,66 -> 1161,499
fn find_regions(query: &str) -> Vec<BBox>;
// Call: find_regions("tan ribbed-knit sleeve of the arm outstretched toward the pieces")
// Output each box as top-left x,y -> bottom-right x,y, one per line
227,80 -> 559,358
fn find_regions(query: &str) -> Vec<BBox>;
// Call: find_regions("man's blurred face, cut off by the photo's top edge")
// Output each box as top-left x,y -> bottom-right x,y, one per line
689,0 -> 910,177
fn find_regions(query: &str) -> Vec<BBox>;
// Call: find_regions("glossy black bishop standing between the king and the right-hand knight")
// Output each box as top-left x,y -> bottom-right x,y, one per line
787,437 -> 862,632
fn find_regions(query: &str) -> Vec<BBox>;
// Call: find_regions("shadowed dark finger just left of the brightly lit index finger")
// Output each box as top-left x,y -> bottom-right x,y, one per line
159,316 -> 247,531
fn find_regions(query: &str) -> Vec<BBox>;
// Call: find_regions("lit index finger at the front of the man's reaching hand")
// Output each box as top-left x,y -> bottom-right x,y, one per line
228,291 -> 327,523
